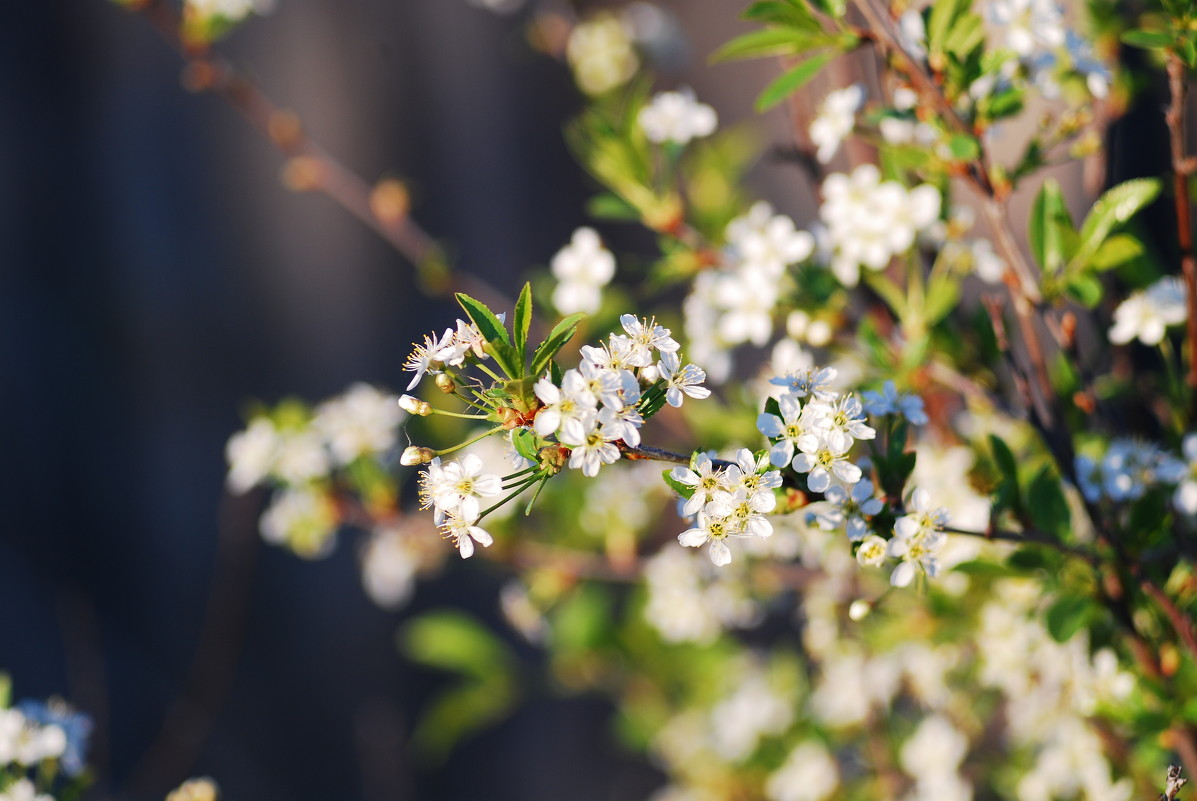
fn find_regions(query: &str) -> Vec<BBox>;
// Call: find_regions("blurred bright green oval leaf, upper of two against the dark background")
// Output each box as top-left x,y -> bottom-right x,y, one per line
400,609 -> 515,679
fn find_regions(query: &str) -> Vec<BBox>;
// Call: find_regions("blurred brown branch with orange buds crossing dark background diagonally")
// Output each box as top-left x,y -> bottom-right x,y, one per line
128,0 -> 511,308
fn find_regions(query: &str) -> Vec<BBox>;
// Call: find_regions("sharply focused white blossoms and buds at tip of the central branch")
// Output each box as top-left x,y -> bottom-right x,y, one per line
400,312 -> 710,558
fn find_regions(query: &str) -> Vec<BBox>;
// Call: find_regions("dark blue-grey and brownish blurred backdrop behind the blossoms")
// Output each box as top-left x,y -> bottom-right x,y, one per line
0,0 -> 804,801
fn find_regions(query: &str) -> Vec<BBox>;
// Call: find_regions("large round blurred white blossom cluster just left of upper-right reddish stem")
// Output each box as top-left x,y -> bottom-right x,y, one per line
819,164 -> 941,286
